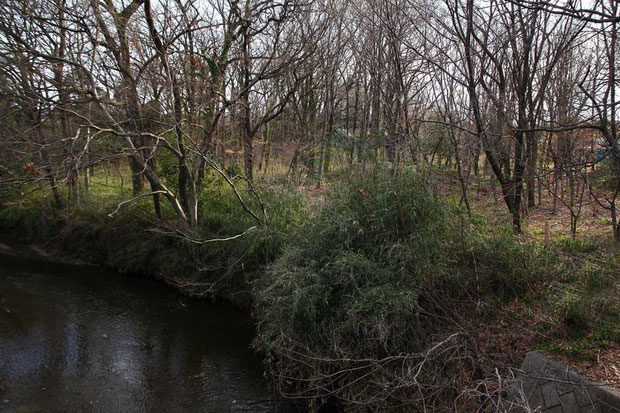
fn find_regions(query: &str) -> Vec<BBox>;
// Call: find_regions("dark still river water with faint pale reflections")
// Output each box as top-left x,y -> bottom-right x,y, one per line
0,255 -> 284,412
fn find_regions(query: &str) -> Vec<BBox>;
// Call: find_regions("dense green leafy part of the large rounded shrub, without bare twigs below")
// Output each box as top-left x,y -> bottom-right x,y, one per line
255,167 -> 457,350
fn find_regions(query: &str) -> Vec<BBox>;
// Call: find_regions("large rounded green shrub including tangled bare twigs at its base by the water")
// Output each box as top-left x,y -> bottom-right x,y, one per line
253,170 -> 544,408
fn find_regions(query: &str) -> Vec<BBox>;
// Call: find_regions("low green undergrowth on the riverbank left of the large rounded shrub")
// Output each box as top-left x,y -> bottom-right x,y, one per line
0,169 -> 307,309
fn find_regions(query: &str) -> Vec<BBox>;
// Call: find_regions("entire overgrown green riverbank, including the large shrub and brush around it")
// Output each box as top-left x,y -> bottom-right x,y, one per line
0,166 -> 620,411
